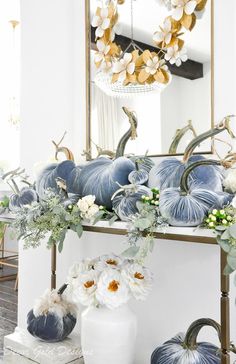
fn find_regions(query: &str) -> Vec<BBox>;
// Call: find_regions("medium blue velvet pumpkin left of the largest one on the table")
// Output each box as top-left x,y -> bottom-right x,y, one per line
36,160 -> 82,198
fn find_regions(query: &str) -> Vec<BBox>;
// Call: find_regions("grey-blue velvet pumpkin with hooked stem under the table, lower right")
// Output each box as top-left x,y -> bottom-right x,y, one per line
151,319 -> 221,364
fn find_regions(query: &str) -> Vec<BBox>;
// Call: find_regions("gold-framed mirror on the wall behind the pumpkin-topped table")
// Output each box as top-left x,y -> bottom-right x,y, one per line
85,0 -> 214,160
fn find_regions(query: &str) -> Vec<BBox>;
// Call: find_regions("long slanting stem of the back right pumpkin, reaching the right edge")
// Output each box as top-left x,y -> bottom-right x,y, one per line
183,115 -> 235,162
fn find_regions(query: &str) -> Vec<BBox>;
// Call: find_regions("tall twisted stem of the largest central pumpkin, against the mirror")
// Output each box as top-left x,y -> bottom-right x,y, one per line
115,106 -> 138,159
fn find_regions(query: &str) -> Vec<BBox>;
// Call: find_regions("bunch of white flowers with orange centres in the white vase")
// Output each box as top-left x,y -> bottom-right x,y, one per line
68,254 -> 152,309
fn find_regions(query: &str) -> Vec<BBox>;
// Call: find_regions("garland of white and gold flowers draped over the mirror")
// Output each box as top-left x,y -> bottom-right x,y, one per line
92,0 -> 207,86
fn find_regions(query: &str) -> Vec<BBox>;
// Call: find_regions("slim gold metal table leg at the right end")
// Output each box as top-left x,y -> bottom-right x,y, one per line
220,249 -> 230,364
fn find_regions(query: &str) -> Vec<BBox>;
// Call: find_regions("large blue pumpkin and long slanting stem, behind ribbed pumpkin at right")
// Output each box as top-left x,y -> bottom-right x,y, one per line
148,118 -> 229,192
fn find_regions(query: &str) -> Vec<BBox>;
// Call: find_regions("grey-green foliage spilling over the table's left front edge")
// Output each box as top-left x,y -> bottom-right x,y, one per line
12,191 -> 83,252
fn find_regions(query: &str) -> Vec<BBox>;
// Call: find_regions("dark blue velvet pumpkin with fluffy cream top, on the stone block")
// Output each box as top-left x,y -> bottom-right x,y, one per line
27,285 -> 76,342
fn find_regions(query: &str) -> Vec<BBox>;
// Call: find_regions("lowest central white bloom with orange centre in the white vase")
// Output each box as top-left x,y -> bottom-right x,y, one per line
96,269 -> 130,309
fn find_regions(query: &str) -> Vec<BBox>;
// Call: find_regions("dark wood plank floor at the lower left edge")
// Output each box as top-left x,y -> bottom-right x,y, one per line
0,267 -> 17,360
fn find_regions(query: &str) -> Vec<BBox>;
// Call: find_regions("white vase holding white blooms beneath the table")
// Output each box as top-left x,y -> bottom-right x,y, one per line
81,305 -> 137,364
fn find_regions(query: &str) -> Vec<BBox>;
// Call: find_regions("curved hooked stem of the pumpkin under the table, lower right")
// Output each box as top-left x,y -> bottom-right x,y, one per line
184,318 -> 221,350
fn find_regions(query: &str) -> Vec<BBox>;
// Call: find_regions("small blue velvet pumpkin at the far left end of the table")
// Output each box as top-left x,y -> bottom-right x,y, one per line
9,187 -> 38,211
